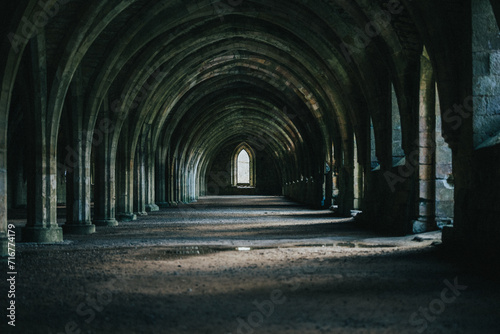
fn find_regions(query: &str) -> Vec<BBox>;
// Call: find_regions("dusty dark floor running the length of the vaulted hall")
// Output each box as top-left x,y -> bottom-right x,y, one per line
0,197 -> 500,334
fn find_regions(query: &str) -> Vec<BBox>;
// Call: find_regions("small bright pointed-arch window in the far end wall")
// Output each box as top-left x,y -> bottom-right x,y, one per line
232,143 -> 255,187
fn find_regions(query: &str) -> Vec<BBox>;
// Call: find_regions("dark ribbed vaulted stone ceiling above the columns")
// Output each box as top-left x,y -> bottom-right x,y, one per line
2,0 -> 472,184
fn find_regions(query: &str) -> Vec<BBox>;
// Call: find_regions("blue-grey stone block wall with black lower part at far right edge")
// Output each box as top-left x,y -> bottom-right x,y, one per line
456,0 -> 500,256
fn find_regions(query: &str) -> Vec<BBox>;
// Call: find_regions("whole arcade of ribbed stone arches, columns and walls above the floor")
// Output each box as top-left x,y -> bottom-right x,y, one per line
0,0 -> 500,255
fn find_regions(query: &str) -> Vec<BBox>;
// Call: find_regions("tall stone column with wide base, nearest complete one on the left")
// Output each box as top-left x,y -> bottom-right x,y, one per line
22,31 -> 63,243
